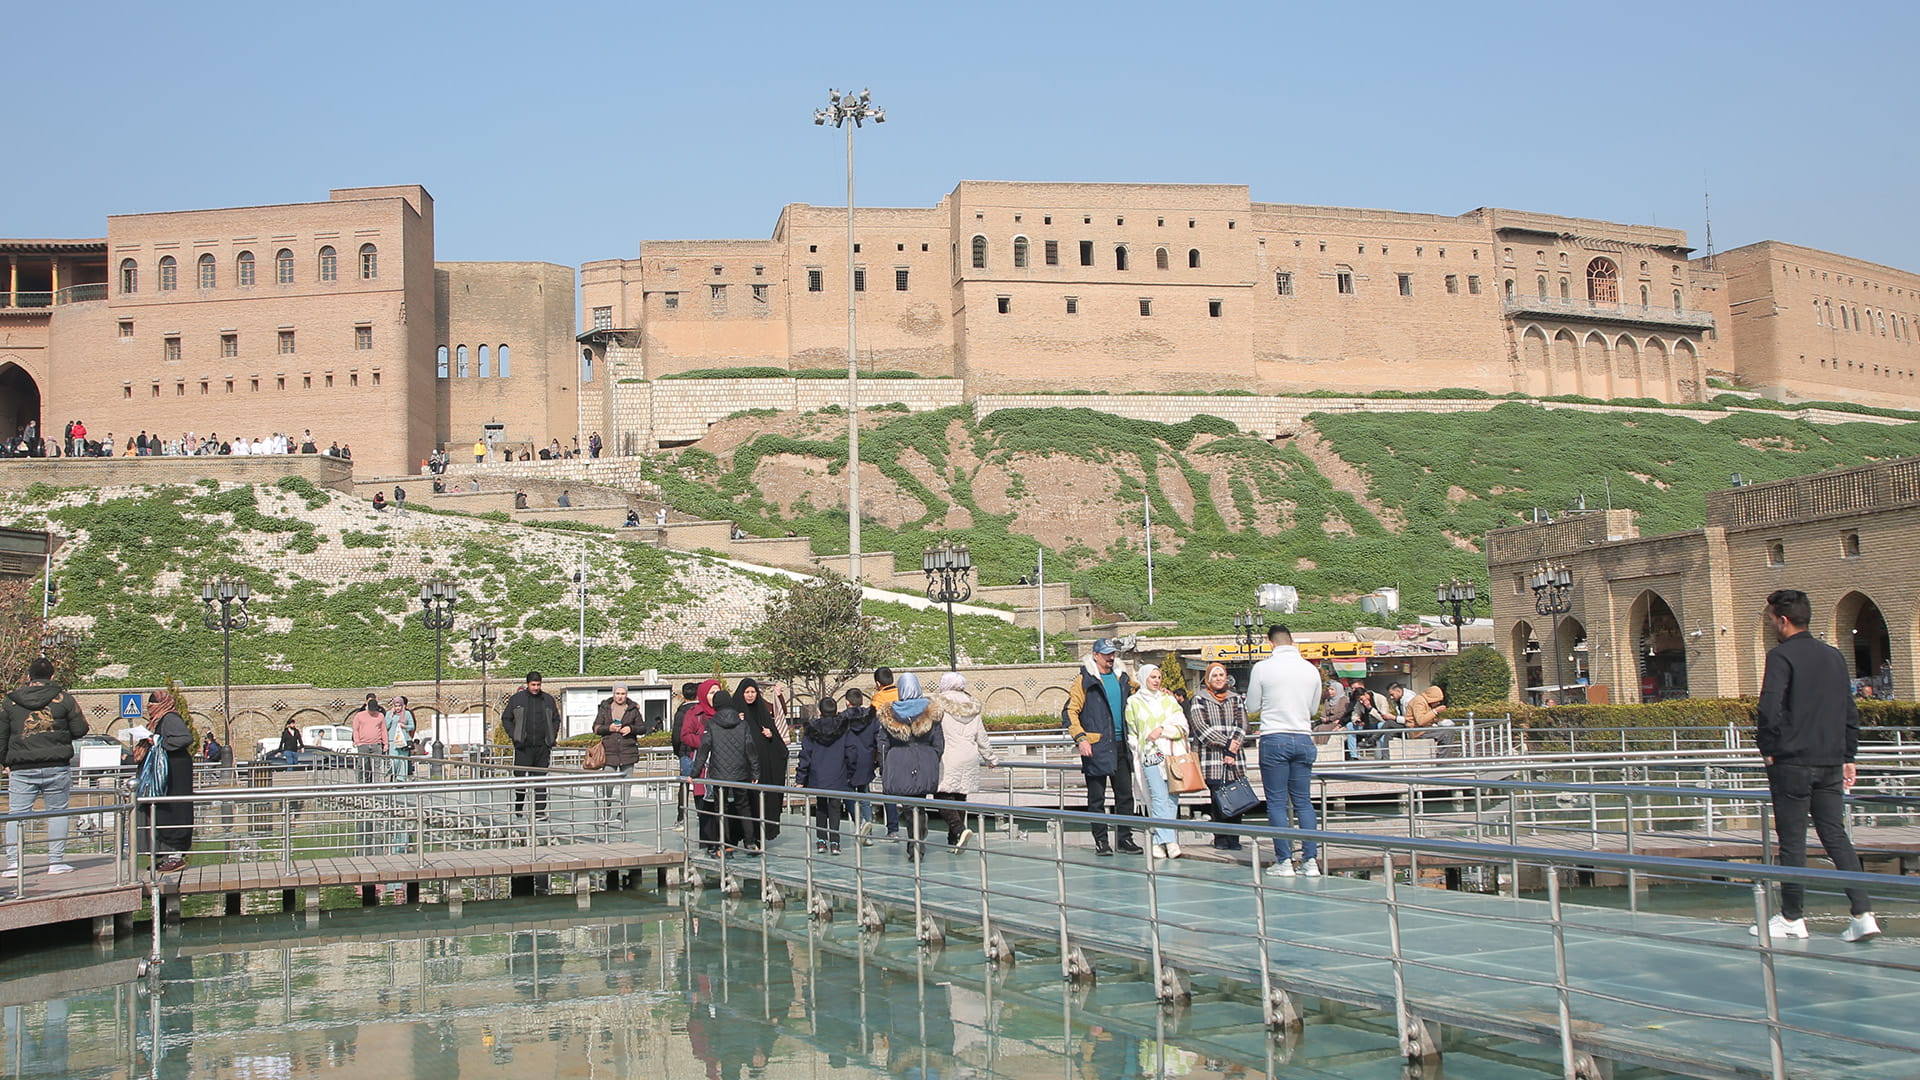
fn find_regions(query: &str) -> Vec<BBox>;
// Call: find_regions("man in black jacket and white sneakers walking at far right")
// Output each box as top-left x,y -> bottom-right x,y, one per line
1749,588 -> 1880,942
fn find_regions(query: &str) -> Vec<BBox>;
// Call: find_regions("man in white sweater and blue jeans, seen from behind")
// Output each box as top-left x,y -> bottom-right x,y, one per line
1246,625 -> 1321,878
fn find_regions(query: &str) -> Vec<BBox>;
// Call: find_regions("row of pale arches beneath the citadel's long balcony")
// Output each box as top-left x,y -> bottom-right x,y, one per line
1521,325 -> 1701,402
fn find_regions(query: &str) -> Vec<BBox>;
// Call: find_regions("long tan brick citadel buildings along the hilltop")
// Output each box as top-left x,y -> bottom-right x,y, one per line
0,181 -> 1920,473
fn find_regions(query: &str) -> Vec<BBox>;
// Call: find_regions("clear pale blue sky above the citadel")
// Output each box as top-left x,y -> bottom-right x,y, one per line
15,0 -> 1920,271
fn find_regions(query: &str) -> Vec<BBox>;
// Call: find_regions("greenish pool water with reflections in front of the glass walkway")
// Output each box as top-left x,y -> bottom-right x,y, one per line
0,894 -> 1681,1080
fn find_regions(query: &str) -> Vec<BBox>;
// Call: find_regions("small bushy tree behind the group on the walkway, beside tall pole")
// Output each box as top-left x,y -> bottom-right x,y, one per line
751,575 -> 879,701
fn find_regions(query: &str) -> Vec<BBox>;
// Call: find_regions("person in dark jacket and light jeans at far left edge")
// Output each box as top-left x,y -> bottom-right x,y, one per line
0,657 -> 86,874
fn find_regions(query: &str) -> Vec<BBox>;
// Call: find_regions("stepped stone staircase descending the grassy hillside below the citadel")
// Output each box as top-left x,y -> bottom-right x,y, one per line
353,459 -> 1094,634
